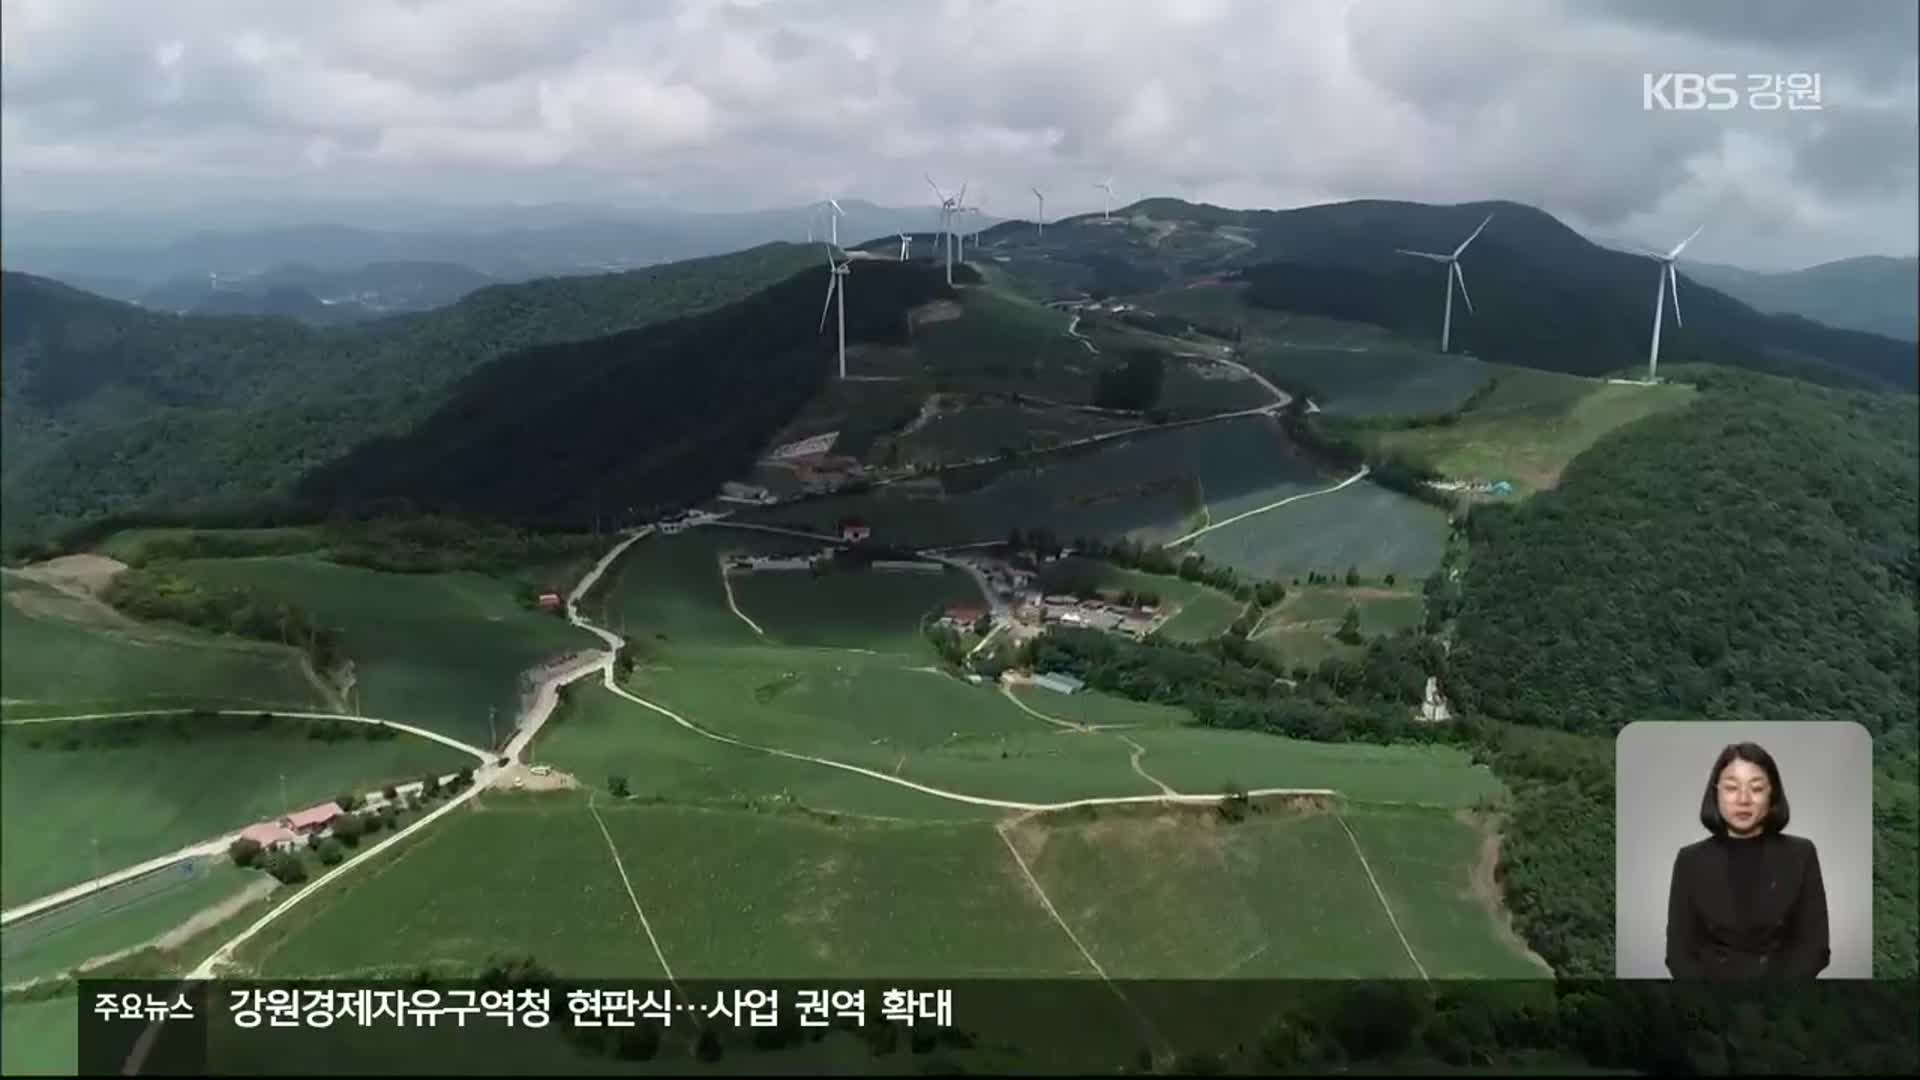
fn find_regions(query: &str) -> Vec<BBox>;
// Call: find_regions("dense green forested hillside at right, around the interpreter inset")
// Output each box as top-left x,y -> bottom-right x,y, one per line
1448,371 -> 1920,976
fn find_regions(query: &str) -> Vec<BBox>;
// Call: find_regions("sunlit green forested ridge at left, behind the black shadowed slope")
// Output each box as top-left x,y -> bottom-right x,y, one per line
0,244 -> 818,544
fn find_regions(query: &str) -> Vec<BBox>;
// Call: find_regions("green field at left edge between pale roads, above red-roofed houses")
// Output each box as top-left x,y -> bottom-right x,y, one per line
0,717 -> 472,907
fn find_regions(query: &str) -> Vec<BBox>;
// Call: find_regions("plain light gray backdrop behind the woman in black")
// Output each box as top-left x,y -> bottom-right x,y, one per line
1613,721 -> 1874,978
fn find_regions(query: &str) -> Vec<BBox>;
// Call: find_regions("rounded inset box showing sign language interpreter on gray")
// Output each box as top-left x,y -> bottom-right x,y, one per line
1615,721 -> 1874,982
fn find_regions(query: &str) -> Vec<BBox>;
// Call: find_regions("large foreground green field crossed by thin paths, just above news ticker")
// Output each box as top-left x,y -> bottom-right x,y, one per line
240,794 -> 1524,980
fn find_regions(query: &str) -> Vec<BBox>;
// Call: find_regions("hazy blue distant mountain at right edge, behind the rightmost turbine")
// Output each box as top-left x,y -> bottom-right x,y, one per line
1680,256 -> 1920,342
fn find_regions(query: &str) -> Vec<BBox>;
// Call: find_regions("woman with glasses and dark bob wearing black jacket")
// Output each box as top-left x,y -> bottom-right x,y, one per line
1667,742 -> 1832,978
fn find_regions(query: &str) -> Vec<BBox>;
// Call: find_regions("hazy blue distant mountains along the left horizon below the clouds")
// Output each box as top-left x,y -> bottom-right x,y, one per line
6,200 -> 993,292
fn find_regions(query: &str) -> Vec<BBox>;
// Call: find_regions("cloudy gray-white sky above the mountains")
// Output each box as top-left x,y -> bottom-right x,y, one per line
0,0 -> 1920,267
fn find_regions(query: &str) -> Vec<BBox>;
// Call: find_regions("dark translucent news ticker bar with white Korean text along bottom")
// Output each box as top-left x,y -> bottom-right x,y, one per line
75,978 -> 1920,1074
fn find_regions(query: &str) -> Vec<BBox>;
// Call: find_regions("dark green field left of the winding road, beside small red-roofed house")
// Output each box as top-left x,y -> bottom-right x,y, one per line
168,557 -> 599,746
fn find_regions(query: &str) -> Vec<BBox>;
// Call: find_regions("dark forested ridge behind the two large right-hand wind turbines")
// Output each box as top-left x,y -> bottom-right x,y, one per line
985,198 -> 1920,390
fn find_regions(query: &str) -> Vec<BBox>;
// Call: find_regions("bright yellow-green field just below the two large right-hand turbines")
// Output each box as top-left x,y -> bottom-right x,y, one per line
1365,367 -> 1695,494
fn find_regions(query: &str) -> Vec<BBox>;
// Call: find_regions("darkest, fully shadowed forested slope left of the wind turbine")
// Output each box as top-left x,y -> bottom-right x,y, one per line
300,253 -> 952,525
